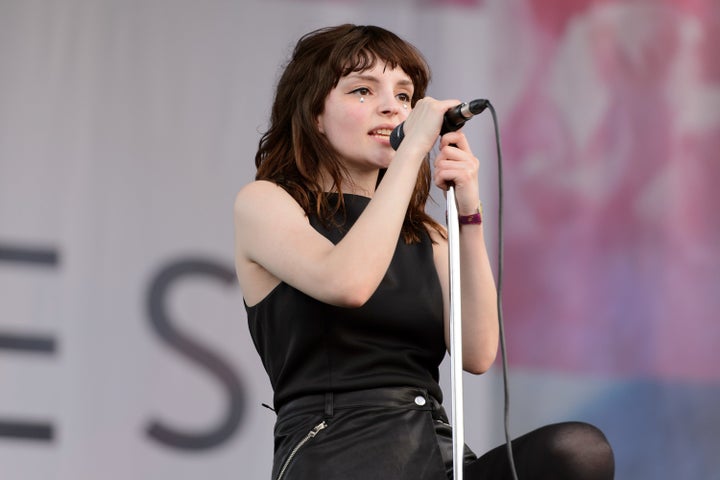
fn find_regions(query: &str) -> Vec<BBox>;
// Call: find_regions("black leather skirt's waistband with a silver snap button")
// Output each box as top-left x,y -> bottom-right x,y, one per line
278,387 -> 442,417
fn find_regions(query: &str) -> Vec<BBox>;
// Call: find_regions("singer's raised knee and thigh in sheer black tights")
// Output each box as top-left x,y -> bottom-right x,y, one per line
462,422 -> 615,480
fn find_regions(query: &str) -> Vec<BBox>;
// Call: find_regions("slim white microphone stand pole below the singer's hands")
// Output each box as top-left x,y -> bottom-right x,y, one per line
447,186 -> 465,480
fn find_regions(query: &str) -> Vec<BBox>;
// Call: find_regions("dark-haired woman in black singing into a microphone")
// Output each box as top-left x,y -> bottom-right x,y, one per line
235,25 -> 613,480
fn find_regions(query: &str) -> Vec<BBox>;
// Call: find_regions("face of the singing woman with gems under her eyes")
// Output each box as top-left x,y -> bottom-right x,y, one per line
317,61 -> 413,174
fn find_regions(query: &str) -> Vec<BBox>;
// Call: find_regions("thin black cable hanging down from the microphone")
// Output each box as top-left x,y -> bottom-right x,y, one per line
487,102 -> 518,480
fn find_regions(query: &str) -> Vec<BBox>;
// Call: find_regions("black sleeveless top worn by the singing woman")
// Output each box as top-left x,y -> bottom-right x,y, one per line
245,194 -> 445,409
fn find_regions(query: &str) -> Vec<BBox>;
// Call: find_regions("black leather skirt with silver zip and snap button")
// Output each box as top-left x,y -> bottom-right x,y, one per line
272,387 -> 476,480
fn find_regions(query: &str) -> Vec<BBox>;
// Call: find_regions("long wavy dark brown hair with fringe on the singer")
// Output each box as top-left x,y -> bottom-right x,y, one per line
255,24 -> 444,243
